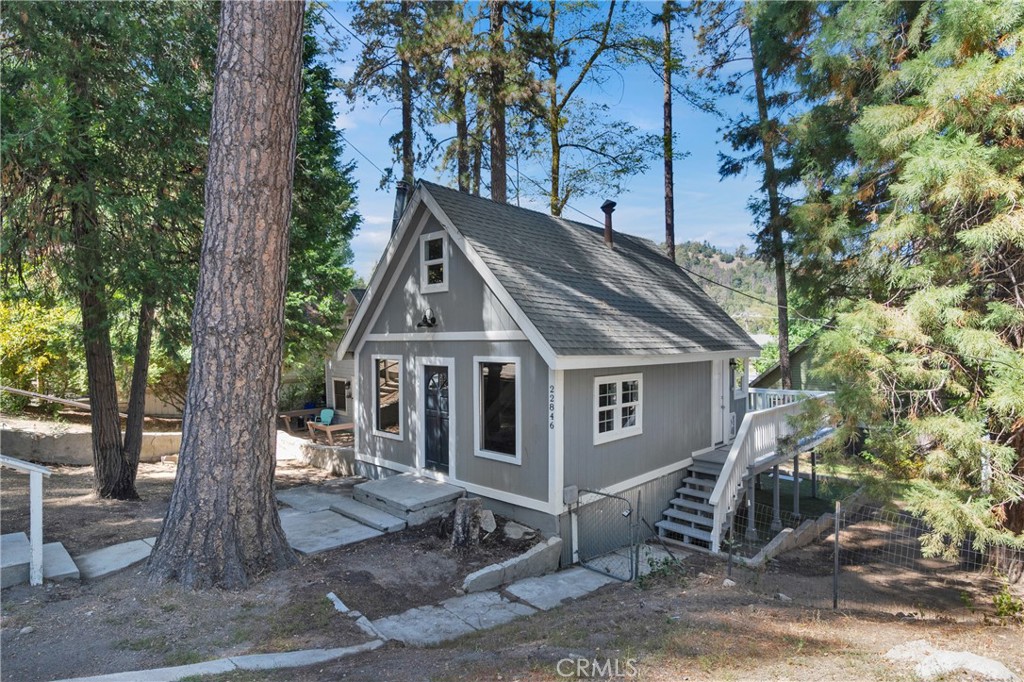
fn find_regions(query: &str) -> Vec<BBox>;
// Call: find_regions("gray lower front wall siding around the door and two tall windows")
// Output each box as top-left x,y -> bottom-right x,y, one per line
356,341 -> 548,502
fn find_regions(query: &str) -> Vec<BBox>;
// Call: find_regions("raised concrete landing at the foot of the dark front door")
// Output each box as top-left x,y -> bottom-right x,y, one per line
352,474 -> 465,526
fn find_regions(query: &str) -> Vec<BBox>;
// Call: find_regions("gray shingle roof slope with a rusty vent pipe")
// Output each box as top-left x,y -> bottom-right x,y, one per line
421,180 -> 758,355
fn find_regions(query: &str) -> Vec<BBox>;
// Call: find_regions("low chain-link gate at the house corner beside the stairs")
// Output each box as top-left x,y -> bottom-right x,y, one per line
572,489 -> 640,581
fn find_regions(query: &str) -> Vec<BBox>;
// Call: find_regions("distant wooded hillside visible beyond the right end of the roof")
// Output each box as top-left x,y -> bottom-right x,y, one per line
676,242 -> 775,334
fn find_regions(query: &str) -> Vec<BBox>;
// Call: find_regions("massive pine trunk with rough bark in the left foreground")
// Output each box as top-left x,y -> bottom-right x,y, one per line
148,0 -> 303,589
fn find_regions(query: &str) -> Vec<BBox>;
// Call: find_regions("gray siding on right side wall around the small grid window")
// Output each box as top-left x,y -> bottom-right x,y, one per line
564,363 -> 712,491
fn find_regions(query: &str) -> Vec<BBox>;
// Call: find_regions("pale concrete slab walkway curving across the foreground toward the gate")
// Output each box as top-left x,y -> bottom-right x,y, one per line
59,567 -> 618,682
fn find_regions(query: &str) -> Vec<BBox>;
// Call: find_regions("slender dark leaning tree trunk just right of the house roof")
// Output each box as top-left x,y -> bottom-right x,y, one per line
746,26 -> 793,390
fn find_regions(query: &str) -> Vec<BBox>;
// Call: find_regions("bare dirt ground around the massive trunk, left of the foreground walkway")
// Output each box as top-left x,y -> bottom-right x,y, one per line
0,462 -> 536,682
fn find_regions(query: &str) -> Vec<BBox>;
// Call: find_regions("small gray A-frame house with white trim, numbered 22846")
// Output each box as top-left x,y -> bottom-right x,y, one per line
330,181 -> 759,557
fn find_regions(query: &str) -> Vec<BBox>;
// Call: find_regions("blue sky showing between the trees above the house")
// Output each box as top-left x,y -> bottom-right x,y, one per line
328,3 -> 757,280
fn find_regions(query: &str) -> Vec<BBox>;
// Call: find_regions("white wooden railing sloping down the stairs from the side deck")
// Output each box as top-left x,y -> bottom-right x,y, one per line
709,389 -> 828,552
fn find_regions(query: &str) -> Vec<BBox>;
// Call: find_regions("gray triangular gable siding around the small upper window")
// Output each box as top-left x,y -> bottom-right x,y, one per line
372,215 -> 519,334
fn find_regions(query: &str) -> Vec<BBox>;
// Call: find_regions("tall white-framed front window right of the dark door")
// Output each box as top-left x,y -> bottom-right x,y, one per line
473,356 -> 522,464
